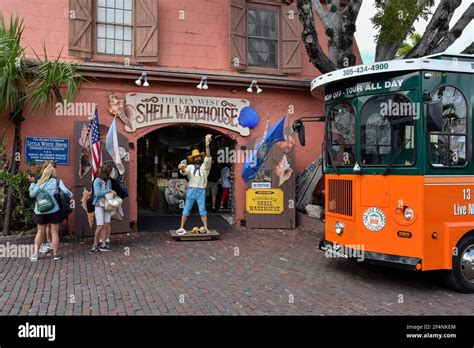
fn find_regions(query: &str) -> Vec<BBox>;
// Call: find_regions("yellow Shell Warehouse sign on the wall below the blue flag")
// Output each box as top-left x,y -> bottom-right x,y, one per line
246,189 -> 285,214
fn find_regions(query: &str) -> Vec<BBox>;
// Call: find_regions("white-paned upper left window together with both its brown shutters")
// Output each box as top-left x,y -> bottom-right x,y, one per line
69,0 -> 158,63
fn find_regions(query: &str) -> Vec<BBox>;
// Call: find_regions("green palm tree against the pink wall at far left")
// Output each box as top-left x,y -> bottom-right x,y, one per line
0,16 -> 82,235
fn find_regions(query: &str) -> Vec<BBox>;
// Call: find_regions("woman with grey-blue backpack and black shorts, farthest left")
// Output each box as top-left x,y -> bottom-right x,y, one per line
29,165 -> 72,261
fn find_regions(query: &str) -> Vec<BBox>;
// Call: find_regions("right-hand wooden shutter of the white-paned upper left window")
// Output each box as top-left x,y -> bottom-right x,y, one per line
134,0 -> 158,63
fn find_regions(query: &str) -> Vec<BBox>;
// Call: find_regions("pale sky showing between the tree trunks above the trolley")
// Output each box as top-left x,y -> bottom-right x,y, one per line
355,0 -> 474,64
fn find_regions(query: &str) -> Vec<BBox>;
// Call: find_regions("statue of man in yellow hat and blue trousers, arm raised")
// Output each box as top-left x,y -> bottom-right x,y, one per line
176,134 -> 212,234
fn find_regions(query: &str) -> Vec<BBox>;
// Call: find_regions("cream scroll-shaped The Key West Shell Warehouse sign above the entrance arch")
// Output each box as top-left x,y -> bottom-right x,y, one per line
114,93 -> 250,136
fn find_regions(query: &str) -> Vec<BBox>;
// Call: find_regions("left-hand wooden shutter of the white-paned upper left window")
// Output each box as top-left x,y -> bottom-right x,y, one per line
69,0 -> 92,58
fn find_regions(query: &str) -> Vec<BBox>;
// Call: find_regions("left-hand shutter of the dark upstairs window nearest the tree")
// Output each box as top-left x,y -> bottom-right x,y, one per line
229,0 -> 247,70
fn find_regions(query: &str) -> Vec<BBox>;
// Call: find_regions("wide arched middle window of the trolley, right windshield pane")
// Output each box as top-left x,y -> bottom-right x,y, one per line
360,94 -> 418,166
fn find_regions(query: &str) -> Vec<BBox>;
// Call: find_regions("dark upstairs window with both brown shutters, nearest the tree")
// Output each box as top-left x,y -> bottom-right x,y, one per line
229,0 -> 302,74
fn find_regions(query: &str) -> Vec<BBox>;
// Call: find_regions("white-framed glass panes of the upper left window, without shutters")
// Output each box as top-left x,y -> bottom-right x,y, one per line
96,0 -> 133,56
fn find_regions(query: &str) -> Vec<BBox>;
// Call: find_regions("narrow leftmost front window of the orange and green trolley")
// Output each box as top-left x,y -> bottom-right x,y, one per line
328,103 -> 356,166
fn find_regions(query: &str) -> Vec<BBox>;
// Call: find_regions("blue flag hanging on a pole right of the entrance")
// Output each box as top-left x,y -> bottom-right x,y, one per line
242,116 -> 286,182
